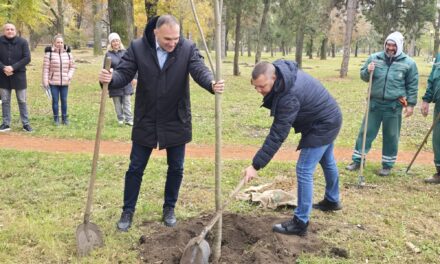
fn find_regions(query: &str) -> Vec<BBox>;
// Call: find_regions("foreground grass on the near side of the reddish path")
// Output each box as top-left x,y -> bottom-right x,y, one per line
0,147 -> 440,263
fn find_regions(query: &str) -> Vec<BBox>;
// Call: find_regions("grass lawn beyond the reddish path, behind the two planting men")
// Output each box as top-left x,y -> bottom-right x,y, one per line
12,47 -> 432,150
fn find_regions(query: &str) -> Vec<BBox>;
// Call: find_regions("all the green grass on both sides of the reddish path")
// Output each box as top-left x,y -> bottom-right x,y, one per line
0,47 -> 440,263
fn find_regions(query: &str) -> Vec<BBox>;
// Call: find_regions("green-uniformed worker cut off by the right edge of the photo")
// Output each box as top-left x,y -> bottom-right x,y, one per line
421,53 -> 440,184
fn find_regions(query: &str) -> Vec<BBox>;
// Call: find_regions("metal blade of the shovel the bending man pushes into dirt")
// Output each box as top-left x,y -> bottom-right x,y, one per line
180,237 -> 211,264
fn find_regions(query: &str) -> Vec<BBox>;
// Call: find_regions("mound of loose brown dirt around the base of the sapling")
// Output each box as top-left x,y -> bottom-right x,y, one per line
140,214 -> 324,264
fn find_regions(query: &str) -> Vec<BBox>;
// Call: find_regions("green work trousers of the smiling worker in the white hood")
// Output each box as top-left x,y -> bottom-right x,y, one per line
352,99 -> 404,168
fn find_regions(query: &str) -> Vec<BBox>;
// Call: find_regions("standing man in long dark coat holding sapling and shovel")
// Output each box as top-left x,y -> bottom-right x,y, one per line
99,15 -> 224,231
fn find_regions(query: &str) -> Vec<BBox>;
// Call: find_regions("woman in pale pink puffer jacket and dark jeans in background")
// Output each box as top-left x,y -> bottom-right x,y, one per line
43,35 -> 75,126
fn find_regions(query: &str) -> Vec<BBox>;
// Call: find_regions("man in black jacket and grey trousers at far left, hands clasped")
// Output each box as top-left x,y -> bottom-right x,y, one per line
0,23 -> 32,132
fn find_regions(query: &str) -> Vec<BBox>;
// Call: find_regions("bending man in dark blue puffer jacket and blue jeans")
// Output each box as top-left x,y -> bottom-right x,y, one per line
244,60 -> 342,236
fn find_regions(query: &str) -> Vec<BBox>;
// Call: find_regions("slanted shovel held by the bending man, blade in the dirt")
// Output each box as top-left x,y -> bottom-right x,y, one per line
180,178 -> 248,264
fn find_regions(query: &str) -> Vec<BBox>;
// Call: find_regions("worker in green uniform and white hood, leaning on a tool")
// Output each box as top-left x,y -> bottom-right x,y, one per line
346,31 -> 419,176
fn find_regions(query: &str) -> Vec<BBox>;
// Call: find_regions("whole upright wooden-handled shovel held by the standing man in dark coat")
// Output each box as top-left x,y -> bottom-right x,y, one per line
76,57 -> 111,257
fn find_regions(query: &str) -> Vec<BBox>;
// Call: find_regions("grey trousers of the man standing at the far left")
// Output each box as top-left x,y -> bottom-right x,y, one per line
0,88 -> 29,126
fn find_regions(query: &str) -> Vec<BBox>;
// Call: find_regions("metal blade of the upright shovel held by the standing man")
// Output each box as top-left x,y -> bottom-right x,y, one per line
76,222 -> 104,257
